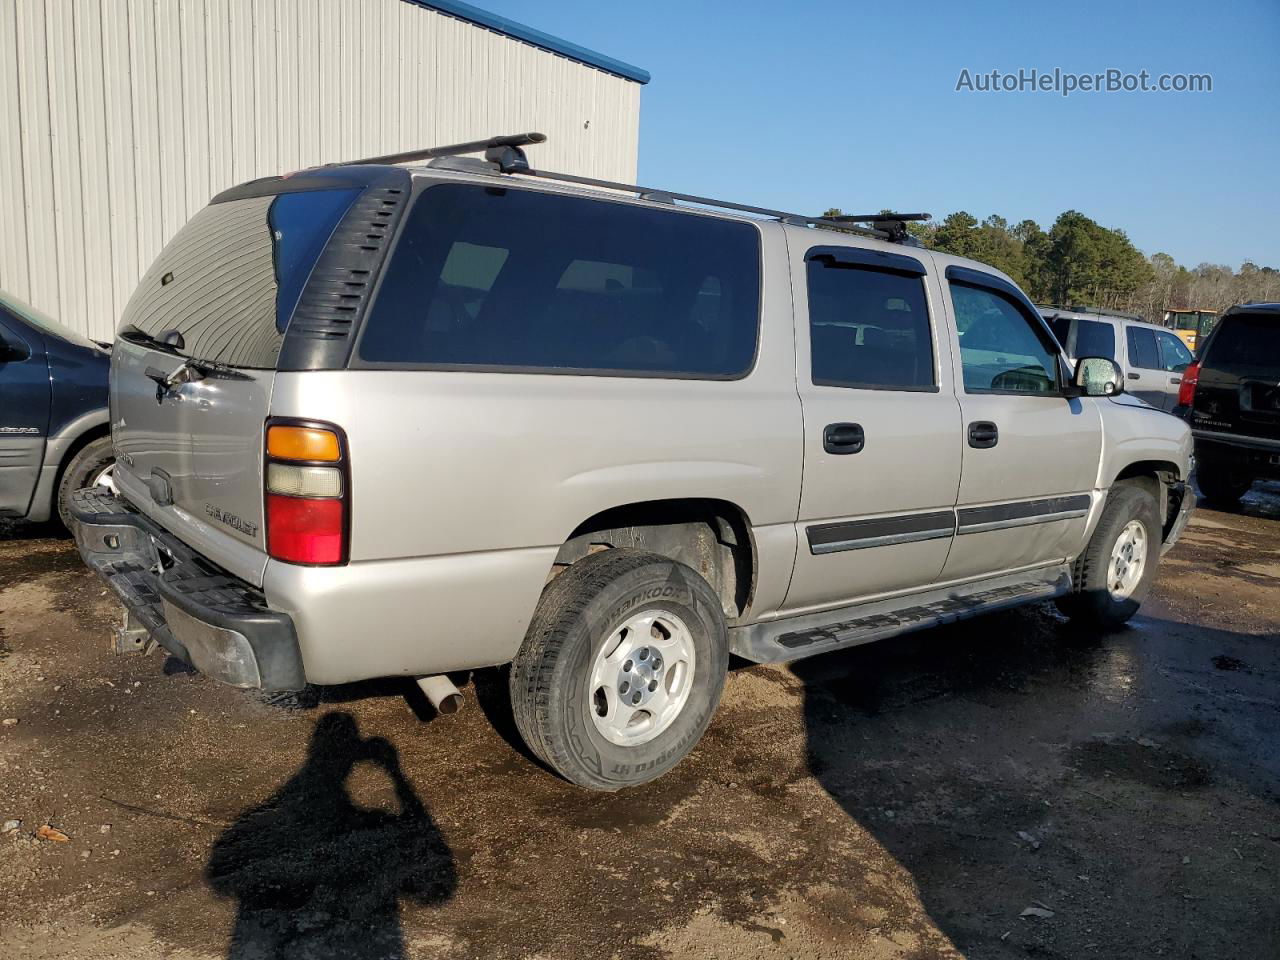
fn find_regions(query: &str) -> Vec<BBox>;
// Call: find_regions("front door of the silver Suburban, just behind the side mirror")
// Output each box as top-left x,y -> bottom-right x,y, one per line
942,266 -> 1102,580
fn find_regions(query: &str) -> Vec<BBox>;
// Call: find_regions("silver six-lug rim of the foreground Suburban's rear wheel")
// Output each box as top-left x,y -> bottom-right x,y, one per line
588,611 -> 695,746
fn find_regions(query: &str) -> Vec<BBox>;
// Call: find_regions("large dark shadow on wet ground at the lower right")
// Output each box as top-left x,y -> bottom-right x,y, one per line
791,604 -> 1280,957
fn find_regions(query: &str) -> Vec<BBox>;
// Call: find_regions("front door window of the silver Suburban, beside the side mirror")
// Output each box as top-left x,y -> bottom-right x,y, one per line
951,280 -> 1059,394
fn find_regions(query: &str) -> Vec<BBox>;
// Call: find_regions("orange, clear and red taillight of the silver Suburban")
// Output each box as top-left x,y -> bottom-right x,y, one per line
262,417 -> 351,567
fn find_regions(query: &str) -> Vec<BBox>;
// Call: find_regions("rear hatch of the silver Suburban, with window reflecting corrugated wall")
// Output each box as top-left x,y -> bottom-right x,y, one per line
111,180 -> 361,585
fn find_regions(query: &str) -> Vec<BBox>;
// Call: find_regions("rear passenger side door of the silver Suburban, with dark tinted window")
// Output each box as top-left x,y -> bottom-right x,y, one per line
785,243 -> 960,612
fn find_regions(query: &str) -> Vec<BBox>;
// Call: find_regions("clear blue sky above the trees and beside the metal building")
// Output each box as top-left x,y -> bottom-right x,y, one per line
474,0 -> 1280,269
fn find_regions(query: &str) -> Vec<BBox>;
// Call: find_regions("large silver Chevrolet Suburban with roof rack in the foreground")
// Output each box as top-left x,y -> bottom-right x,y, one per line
67,138 -> 1192,790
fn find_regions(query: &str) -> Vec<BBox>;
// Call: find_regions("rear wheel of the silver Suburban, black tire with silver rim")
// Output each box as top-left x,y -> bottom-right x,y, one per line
511,549 -> 728,791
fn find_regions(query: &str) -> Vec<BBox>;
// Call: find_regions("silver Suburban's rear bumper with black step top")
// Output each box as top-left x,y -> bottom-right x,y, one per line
72,488 -> 306,690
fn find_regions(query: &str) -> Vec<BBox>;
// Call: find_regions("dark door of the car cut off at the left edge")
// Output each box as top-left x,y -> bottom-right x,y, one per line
0,316 -> 49,516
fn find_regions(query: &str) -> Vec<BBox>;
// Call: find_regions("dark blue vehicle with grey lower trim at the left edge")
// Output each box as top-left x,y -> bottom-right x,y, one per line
0,291 -> 114,524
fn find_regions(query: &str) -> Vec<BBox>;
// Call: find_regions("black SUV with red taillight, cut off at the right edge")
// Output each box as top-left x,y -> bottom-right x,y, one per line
1174,303 -> 1280,502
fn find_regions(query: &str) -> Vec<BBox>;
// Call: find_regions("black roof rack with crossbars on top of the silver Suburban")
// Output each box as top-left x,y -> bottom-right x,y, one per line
350,133 -> 931,243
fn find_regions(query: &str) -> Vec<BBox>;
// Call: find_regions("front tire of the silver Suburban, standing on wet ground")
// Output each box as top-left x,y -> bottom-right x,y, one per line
1057,484 -> 1162,628
